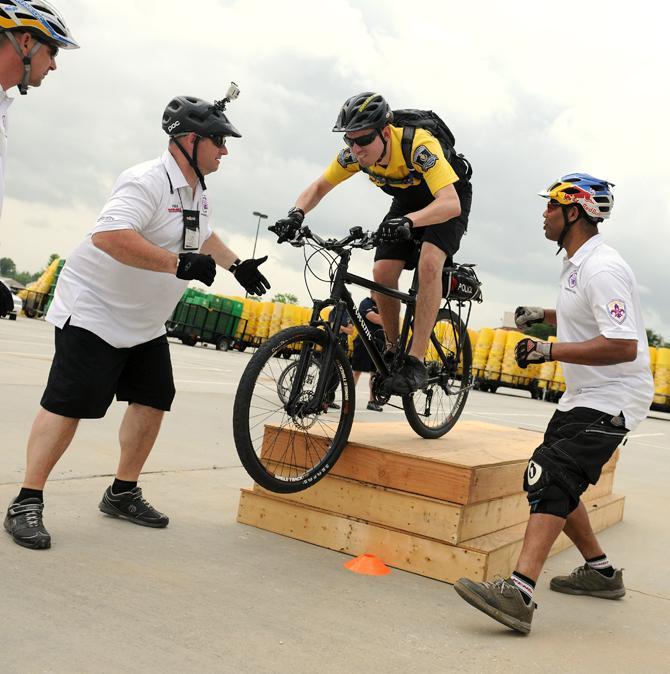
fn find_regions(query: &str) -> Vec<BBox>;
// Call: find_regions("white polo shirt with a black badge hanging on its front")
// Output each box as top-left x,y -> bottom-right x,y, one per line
46,151 -> 212,348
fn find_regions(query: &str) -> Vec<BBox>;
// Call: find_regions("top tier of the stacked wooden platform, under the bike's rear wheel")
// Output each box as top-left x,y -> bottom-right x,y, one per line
262,421 -> 618,504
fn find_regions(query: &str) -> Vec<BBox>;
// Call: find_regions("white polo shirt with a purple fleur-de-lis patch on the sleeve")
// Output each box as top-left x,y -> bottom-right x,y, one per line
556,234 -> 654,431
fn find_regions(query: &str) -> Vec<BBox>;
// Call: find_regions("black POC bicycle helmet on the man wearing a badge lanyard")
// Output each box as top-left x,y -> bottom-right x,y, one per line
163,96 -> 242,138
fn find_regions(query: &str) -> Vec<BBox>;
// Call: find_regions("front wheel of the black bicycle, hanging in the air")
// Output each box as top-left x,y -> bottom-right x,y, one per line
233,326 -> 355,493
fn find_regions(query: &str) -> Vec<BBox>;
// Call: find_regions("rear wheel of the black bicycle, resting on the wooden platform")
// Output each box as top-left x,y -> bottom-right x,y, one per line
402,309 -> 472,438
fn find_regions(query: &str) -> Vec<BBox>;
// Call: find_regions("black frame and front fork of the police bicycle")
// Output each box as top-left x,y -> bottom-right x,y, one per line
286,242 -> 471,414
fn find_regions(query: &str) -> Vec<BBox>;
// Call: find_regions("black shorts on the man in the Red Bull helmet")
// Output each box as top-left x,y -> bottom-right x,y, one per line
524,407 -> 628,512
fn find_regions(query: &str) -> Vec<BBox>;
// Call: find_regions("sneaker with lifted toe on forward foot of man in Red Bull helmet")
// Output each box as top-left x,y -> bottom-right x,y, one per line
454,578 -> 537,634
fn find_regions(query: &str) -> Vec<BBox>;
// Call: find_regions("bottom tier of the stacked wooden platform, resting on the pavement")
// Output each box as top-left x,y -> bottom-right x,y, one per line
237,490 -> 623,583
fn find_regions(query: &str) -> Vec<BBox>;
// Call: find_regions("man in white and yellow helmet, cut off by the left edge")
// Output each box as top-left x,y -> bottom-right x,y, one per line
0,0 -> 79,316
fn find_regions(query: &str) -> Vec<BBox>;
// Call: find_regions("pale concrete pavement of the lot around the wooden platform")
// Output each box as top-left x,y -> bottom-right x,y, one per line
0,318 -> 670,674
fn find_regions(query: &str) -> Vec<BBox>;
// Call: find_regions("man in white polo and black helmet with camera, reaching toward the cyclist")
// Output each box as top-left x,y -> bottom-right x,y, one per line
5,96 -> 270,549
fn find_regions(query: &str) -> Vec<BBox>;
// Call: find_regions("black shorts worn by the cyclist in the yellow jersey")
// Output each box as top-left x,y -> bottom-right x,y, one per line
375,181 -> 472,269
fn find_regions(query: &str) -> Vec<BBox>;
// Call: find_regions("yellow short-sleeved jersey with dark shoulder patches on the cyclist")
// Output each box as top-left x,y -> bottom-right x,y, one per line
323,125 -> 458,195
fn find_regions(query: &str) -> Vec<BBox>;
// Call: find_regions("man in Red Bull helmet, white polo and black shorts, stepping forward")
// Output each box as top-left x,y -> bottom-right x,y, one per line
454,173 -> 654,633
